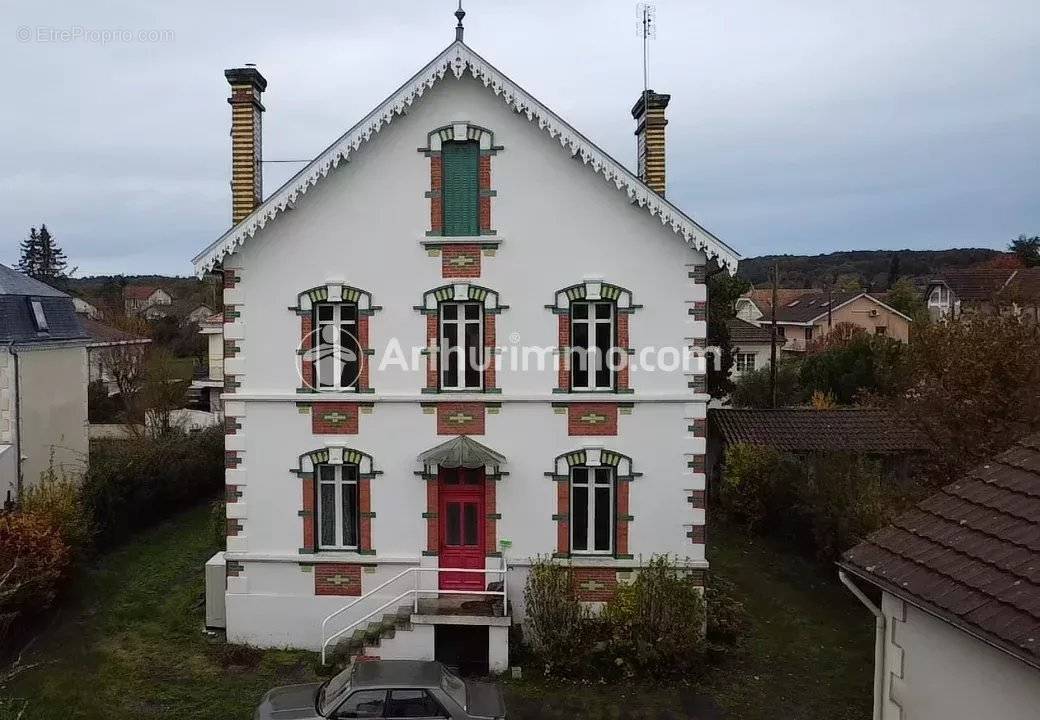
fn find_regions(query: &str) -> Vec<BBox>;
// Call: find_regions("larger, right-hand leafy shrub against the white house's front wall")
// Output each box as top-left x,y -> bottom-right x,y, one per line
603,556 -> 704,677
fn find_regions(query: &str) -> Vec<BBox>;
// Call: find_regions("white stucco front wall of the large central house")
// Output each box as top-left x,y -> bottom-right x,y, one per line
196,43 -> 732,669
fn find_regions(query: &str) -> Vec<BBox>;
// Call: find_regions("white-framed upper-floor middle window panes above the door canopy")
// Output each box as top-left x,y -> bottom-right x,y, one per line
439,302 -> 484,390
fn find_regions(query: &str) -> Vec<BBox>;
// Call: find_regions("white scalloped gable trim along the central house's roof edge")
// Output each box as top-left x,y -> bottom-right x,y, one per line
192,41 -> 739,275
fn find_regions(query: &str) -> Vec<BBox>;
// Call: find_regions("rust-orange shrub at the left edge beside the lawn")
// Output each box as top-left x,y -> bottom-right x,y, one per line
0,513 -> 70,647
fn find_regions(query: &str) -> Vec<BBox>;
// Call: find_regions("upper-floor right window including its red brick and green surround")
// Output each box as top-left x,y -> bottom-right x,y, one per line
545,280 -> 643,393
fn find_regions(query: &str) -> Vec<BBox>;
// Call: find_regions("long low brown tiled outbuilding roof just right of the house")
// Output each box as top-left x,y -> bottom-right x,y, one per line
708,408 -> 930,454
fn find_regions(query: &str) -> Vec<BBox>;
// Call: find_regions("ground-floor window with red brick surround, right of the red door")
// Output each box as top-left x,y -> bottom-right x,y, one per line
546,447 -> 640,560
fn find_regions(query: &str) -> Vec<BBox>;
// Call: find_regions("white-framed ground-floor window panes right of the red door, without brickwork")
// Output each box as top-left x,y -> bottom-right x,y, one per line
571,465 -> 616,555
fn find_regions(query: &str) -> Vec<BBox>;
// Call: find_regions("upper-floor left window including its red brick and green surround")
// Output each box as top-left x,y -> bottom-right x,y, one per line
289,282 -> 382,392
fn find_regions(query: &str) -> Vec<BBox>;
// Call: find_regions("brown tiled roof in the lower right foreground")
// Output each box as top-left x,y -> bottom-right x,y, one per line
840,434 -> 1040,667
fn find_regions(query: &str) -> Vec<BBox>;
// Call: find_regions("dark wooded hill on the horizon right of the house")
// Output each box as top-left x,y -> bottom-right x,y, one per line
736,248 -> 1008,290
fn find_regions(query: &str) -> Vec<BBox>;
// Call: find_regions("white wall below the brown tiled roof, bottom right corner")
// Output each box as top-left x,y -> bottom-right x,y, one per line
882,593 -> 1040,720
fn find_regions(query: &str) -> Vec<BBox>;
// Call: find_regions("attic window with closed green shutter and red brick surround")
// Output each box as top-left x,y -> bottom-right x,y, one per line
419,122 -> 502,237
